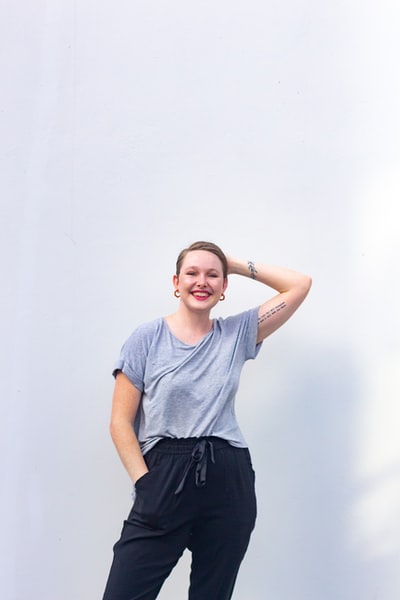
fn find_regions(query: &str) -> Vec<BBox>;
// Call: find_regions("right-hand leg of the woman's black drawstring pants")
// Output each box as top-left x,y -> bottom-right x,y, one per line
189,446 -> 256,600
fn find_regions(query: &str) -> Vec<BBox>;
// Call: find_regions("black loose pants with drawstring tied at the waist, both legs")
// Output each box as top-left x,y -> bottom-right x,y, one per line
103,437 -> 256,600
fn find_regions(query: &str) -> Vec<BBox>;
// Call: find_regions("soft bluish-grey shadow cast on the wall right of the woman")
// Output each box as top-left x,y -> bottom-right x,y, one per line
235,336 -> 398,600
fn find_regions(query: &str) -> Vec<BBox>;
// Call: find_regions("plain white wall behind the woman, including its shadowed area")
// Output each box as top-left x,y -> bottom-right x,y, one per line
0,0 -> 400,600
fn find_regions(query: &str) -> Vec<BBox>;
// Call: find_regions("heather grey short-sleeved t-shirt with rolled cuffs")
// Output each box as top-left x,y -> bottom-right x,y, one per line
114,308 -> 261,454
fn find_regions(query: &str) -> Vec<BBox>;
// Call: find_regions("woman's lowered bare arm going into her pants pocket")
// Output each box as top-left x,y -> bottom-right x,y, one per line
110,371 -> 148,483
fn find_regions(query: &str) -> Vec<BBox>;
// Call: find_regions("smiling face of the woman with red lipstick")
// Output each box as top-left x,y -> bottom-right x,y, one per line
173,250 -> 228,310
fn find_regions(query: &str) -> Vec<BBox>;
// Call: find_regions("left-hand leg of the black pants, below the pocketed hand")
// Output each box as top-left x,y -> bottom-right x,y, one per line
103,451 -> 190,600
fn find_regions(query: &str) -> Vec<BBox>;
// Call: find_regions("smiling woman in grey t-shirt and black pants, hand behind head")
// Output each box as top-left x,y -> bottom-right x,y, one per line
103,242 -> 311,600
